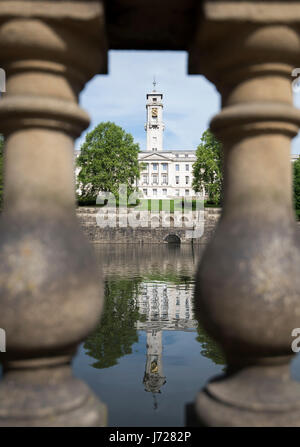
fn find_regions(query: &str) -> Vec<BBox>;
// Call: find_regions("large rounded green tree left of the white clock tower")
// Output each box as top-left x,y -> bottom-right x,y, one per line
77,122 -> 140,201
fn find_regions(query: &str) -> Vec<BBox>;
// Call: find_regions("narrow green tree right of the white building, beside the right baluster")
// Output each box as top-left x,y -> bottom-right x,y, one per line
193,130 -> 223,205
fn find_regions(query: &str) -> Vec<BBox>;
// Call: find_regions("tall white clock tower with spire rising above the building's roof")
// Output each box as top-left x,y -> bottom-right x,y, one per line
145,80 -> 165,152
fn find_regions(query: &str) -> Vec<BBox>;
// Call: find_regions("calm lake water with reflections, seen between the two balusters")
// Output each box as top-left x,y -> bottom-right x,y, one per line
74,245 -> 224,426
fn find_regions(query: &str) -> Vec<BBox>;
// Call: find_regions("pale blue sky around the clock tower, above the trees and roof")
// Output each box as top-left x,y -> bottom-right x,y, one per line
75,51 -> 300,153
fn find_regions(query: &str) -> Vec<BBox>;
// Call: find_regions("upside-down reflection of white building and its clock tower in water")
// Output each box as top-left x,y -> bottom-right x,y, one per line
137,282 -> 197,408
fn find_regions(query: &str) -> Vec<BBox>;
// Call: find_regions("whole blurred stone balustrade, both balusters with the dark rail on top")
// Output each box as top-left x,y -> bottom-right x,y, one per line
0,0 -> 300,426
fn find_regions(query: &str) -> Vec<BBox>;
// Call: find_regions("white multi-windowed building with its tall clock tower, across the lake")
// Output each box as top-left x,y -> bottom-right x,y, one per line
137,82 -> 196,199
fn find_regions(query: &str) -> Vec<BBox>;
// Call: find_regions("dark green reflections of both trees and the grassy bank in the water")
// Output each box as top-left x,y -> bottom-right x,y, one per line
84,272 -> 226,378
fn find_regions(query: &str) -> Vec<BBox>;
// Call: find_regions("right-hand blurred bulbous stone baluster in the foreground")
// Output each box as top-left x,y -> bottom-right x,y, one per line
190,1 -> 300,426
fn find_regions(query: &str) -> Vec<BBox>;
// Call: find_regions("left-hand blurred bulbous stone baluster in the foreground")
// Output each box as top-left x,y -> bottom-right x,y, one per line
0,1 -> 106,426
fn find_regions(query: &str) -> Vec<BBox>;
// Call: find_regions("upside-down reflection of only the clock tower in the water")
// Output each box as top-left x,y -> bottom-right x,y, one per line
143,329 -> 166,408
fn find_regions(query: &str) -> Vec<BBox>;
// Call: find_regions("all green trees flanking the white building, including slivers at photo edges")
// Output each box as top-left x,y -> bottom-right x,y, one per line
0,121 -> 300,214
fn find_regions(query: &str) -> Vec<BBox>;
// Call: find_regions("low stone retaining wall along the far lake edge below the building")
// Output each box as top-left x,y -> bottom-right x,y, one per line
77,207 -> 221,244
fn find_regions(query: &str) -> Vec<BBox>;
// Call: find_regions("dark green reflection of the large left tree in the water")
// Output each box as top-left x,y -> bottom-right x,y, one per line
84,278 -> 141,368
